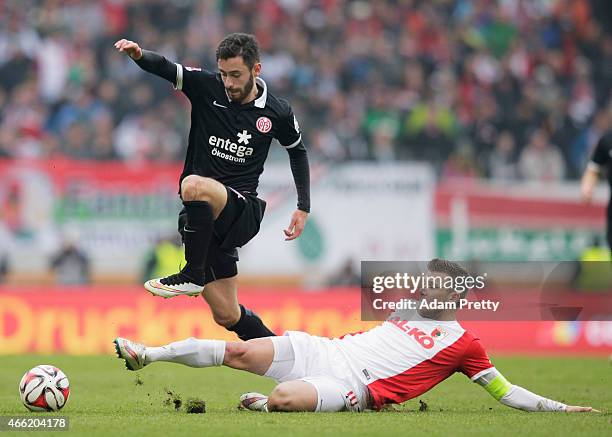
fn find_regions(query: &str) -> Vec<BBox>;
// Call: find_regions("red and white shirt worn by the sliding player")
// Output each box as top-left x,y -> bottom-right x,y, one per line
332,316 -> 493,409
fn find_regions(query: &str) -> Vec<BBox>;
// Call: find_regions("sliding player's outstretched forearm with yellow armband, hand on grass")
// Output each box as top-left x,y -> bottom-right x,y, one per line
475,368 -> 599,413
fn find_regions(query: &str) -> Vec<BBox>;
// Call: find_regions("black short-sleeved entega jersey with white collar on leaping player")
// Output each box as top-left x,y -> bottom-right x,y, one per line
175,64 -> 301,193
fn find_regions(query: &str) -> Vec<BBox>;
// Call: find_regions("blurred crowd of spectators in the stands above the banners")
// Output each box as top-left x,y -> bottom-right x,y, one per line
0,0 -> 612,181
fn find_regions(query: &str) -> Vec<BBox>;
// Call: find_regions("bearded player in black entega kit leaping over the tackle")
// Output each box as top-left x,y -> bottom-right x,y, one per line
115,33 -> 310,340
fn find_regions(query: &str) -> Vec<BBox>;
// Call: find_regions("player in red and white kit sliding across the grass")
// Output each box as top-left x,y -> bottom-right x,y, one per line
115,259 -> 596,412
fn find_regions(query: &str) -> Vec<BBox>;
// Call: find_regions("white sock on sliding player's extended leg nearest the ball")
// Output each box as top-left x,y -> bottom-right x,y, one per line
145,337 -> 225,367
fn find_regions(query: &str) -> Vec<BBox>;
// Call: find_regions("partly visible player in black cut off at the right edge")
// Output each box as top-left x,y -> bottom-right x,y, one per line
581,131 -> 612,251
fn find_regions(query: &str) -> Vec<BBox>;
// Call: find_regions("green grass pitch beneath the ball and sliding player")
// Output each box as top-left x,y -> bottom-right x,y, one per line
0,353 -> 612,437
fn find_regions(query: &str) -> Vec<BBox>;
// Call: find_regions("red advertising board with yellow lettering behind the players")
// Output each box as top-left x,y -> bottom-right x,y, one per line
0,287 -> 612,356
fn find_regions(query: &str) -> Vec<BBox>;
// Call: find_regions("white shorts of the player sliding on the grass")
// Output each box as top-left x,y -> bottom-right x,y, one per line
266,331 -> 369,412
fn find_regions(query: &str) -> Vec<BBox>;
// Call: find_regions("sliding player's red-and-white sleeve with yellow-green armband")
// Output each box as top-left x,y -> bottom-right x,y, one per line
460,339 -> 567,411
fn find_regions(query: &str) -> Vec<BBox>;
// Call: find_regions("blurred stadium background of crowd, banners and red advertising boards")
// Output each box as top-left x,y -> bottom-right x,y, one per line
0,0 -> 612,355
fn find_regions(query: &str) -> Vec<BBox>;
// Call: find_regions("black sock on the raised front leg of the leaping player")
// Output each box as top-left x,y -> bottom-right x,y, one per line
182,200 -> 214,285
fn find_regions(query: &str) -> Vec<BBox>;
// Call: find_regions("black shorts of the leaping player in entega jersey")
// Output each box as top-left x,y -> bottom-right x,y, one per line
178,187 -> 266,284
